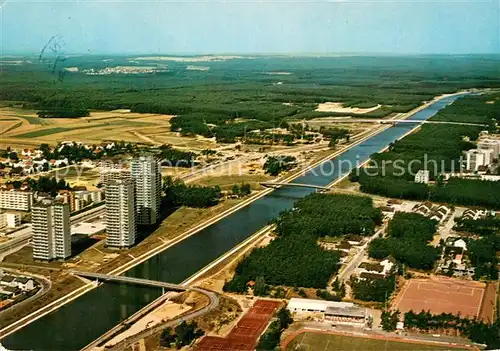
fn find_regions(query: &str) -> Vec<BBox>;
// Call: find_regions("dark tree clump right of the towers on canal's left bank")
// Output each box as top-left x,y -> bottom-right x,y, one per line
163,177 -> 221,207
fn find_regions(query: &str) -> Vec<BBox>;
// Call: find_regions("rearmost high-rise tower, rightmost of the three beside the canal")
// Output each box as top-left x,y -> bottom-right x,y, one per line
131,156 -> 161,225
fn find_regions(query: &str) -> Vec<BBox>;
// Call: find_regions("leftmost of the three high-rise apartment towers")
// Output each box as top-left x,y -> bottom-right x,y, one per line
31,199 -> 71,261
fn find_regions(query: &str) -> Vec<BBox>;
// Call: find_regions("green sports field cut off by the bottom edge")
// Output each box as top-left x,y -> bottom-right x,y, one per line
285,332 -> 466,351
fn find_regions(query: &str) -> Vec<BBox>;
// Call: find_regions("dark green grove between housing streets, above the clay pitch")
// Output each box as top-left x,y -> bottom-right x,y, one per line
368,212 -> 440,270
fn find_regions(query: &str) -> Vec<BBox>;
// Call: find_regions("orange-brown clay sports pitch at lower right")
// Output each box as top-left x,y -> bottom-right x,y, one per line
392,277 -> 485,318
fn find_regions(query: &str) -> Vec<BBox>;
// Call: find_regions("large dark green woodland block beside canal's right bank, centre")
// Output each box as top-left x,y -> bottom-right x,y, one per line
224,193 -> 382,292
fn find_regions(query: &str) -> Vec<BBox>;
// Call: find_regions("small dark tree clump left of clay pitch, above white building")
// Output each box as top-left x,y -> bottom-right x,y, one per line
350,274 -> 396,302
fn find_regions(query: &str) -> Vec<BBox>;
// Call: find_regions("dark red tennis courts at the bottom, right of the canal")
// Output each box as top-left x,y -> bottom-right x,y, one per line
195,300 -> 281,351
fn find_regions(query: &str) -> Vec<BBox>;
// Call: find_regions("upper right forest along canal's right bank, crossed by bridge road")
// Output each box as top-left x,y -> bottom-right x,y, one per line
350,94 -> 500,209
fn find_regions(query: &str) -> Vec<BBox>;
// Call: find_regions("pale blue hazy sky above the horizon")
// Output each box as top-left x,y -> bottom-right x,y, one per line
0,0 -> 500,54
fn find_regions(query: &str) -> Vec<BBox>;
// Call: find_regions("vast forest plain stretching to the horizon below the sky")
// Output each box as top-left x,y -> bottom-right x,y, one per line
0,55 -> 500,141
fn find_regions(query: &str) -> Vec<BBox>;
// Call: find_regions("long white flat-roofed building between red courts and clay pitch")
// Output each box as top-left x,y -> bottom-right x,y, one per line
287,298 -> 368,327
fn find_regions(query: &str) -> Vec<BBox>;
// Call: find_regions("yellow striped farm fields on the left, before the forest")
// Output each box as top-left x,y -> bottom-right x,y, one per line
0,107 -> 215,150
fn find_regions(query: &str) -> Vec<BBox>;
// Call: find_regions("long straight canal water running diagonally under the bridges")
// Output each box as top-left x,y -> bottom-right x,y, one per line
1,94 -> 465,351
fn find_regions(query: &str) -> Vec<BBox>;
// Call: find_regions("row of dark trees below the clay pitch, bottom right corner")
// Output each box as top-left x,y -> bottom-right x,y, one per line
404,310 -> 500,349
